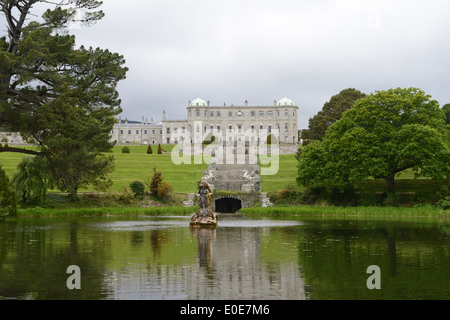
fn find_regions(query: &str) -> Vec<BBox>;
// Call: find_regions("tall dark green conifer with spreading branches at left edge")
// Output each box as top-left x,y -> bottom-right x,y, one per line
0,0 -> 127,198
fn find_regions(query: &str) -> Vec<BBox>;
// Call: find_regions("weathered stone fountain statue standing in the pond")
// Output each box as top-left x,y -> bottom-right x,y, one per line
190,180 -> 219,228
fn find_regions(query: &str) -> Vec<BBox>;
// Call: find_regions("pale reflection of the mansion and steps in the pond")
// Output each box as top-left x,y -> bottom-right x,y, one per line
104,227 -> 306,300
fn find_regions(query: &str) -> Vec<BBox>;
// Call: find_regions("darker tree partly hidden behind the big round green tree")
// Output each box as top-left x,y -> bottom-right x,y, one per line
302,88 -> 366,140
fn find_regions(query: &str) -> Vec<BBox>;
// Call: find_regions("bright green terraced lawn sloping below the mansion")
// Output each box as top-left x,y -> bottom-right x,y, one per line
0,145 -> 444,193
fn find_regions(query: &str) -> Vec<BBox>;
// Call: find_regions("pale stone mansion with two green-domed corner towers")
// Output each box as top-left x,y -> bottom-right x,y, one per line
111,98 -> 298,144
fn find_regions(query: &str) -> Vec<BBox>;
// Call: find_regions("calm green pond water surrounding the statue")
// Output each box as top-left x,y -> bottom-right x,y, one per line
0,217 -> 450,300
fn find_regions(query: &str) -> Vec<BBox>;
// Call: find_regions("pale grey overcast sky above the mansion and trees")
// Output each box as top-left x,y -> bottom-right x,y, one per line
16,0 -> 450,128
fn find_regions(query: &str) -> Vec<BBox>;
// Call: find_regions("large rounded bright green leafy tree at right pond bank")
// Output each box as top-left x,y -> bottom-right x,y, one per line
297,88 -> 450,193
